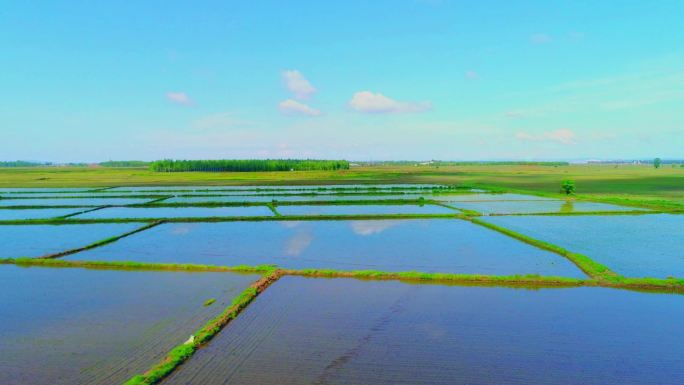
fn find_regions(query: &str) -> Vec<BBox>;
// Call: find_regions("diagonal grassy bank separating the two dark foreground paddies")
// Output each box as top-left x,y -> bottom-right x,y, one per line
124,271 -> 280,385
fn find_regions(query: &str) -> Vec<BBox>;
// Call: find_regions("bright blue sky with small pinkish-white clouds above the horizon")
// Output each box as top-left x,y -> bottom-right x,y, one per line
0,0 -> 684,162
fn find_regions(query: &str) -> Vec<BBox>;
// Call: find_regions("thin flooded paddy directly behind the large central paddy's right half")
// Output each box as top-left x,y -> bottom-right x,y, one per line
277,204 -> 457,215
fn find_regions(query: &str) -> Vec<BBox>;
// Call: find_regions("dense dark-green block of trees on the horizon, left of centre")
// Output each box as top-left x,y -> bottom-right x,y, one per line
150,159 -> 349,172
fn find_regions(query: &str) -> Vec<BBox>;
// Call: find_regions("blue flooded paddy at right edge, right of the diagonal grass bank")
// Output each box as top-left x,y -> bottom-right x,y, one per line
485,214 -> 684,278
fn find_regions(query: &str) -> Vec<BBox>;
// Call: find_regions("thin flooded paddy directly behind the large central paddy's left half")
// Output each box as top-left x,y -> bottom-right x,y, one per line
73,206 -> 273,219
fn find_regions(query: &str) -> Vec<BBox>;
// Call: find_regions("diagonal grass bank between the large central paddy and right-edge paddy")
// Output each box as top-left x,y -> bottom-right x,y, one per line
470,218 -> 618,279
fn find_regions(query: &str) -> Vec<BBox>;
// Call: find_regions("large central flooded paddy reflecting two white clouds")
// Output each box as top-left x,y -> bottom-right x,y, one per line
66,219 -> 585,277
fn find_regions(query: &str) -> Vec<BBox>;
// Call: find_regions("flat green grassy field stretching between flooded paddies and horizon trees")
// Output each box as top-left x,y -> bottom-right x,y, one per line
0,165 -> 684,205
